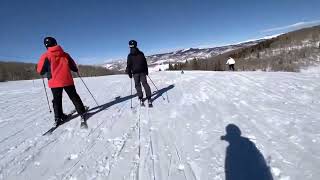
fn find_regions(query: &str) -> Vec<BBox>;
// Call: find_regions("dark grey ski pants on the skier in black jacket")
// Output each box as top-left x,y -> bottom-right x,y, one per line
133,73 -> 151,99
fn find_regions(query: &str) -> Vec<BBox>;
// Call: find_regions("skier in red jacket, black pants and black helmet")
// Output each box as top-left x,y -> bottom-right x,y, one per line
37,37 -> 86,126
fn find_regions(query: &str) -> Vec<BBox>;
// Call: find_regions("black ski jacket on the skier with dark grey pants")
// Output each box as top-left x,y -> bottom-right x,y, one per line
126,48 -> 148,75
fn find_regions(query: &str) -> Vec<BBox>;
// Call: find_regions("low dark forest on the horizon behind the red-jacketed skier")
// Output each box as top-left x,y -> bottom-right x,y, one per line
0,61 -> 120,82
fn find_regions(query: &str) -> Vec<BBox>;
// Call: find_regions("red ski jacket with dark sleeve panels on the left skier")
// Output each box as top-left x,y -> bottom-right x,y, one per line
37,45 -> 78,88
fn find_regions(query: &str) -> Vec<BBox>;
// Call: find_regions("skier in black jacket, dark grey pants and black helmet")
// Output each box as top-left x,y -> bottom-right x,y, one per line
126,40 -> 152,106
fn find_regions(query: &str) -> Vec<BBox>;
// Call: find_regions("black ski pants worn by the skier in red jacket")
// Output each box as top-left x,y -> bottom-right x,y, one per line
51,85 -> 85,119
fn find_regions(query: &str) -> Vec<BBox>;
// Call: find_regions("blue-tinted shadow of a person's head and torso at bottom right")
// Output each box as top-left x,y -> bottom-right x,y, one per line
221,124 -> 273,180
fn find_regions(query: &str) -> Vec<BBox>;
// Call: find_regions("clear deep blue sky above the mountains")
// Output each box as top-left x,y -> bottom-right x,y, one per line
0,0 -> 320,64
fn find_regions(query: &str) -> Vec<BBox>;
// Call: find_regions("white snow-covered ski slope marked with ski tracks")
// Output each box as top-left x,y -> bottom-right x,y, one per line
0,71 -> 320,180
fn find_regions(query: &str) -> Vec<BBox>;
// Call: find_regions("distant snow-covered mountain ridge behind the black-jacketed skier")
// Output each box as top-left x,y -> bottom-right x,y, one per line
102,37 -> 264,71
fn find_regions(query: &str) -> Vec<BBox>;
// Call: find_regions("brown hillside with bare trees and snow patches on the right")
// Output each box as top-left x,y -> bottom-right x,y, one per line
199,26 -> 320,72
